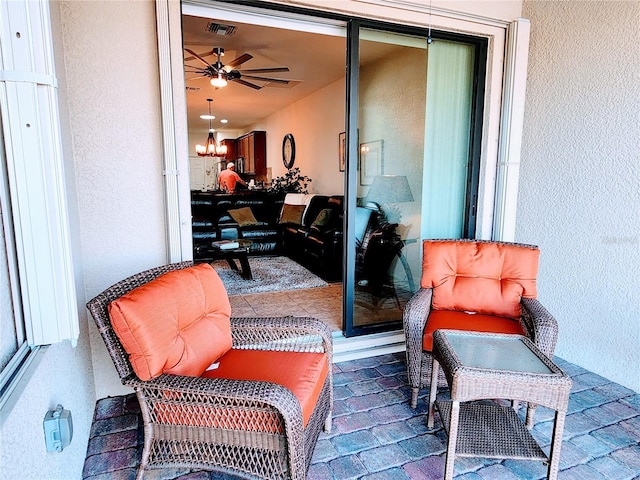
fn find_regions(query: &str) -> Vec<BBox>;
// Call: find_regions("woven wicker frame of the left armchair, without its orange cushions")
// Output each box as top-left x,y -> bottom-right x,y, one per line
87,262 -> 333,479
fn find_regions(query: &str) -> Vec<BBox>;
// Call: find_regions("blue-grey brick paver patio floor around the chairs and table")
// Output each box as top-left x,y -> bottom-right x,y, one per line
83,350 -> 640,480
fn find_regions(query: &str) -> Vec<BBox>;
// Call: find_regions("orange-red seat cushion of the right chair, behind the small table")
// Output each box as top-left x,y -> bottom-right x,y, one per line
422,310 -> 526,352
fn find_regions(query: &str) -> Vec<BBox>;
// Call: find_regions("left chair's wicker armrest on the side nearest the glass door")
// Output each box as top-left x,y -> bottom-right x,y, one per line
231,317 -> 333,361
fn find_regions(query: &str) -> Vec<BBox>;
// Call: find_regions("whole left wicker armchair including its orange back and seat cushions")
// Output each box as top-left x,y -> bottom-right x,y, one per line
87,262 -> 333,479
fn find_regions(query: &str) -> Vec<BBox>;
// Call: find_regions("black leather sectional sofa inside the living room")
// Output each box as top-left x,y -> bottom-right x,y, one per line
191,191 -> 395,283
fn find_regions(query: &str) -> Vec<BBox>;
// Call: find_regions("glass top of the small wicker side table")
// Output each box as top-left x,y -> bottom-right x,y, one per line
446,331 -> 554,374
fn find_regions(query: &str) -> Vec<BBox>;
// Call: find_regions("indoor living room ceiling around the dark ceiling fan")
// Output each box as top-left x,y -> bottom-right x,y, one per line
182,15 -> 346,135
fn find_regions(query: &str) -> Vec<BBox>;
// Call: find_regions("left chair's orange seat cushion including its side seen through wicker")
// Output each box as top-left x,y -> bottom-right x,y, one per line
154,349 -> 329,433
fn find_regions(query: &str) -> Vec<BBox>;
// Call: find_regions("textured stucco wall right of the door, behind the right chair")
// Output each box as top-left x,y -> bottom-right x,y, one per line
516,1 -> 640,391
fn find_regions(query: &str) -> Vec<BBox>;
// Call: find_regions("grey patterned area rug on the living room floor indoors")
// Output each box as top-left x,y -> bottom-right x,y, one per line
211,257 -> 328,295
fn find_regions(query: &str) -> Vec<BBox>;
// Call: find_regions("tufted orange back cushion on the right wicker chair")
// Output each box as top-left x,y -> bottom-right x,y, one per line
420,240 -> 540,319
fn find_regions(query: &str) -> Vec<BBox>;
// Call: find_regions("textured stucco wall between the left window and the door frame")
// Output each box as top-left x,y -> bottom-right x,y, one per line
59,1 -> 167,398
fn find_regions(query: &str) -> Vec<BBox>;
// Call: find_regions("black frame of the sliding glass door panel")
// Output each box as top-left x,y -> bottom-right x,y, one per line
342,19 -> 489,337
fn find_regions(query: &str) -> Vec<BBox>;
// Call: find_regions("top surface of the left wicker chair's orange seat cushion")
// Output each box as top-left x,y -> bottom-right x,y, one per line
202,349 -> 329,427
